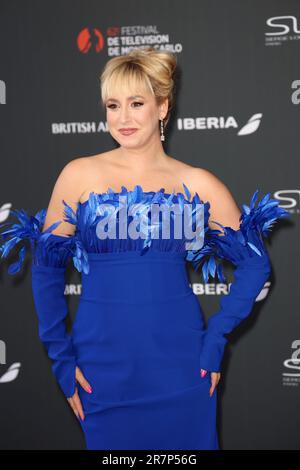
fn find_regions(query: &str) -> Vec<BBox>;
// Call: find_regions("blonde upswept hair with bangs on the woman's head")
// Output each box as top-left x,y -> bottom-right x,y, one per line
100,47 -> 177,126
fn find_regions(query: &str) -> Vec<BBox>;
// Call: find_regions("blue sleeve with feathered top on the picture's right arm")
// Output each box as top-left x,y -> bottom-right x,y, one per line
186,190 -> 289,372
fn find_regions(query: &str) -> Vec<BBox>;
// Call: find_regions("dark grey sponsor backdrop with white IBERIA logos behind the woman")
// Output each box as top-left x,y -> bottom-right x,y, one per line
0,0 -> 300,449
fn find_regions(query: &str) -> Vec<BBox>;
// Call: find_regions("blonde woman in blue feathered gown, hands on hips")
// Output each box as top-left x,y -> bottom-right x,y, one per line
2,48 -> 287,449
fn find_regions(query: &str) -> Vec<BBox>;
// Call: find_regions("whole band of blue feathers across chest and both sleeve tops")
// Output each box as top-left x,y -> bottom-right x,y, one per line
0,183 -> 289,282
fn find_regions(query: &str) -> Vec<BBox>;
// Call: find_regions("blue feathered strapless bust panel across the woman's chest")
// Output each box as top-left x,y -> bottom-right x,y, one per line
71,185 -> 209,254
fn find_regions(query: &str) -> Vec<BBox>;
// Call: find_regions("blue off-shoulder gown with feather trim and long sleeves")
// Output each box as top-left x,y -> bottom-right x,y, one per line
1,184 -> 288,450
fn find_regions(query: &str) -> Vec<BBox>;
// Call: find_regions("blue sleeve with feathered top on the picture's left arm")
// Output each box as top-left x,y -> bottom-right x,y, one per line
0,205 -> 88,397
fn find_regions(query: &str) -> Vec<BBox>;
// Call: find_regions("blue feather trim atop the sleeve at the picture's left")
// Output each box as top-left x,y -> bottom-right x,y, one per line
0,206 -> 89,275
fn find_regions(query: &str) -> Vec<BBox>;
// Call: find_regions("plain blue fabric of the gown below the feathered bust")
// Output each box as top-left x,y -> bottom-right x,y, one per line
72,251 -> 219,450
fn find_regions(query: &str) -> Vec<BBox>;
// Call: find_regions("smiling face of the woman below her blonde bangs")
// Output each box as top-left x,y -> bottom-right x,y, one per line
106,86 -> 168,148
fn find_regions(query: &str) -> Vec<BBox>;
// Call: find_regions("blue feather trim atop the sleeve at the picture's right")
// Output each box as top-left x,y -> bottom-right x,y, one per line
186,189 -> 289,283
